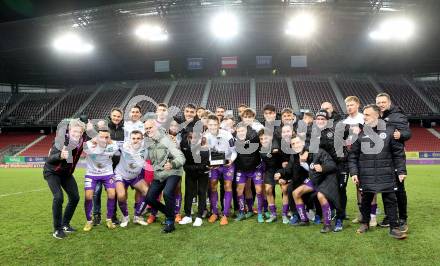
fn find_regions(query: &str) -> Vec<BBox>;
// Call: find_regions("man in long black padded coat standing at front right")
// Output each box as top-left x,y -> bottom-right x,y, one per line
348,105 -> 406,239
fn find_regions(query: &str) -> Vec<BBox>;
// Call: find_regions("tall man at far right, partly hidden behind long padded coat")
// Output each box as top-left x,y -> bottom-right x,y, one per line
376,93 -> 411,232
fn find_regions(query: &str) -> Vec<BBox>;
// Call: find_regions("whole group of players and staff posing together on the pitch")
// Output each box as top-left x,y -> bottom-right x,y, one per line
43,90 -> 411,239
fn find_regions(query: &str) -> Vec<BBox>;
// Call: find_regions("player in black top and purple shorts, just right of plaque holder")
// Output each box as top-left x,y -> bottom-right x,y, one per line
235,122 -> 264,223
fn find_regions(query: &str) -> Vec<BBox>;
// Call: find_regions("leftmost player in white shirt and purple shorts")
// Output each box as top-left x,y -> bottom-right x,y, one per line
84,129 -> 119,231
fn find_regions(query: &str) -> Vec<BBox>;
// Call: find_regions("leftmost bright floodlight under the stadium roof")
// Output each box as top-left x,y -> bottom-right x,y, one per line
53,33 -> 94,54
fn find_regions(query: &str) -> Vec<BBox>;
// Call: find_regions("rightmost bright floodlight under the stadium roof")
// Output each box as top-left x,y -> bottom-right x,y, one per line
369,18 -> 415,41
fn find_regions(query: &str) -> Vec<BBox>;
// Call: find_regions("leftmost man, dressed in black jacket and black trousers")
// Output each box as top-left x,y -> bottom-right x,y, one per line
43,119 -> 86,239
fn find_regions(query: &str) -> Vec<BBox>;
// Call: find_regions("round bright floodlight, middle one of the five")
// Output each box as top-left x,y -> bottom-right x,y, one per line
211,12 -> 238,39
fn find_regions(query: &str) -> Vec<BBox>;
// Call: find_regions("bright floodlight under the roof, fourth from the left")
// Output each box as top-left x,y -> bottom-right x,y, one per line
285,13 -> 317,39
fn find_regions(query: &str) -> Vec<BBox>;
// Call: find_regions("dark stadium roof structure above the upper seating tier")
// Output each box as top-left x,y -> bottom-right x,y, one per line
0,0 -> 440,84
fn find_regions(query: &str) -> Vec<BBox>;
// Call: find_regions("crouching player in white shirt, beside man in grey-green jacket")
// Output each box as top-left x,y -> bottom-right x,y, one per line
115,130 -> 148,227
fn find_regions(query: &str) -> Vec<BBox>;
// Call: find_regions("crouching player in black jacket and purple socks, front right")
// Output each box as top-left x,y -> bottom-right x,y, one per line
292,137 -> 340,233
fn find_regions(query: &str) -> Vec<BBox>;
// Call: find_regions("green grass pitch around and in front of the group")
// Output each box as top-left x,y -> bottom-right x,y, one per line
0,166 -> 440,265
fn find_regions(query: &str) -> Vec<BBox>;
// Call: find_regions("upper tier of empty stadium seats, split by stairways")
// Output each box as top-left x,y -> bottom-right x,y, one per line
0,74 -> 440,126
